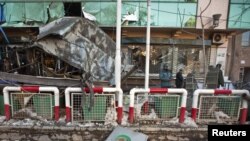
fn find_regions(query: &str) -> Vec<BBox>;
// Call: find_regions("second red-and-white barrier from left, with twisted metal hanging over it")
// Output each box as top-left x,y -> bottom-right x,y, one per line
65,87 -> 123,123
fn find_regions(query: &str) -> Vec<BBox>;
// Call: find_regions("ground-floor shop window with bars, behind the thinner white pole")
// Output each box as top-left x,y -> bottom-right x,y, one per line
131,45 -> 209,76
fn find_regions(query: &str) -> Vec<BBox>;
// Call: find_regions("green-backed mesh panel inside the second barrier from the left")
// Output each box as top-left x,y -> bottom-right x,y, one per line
71,93 -> 116,122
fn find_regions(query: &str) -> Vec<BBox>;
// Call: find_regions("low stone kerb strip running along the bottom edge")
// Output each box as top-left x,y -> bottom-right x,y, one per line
0,126 -> 207,141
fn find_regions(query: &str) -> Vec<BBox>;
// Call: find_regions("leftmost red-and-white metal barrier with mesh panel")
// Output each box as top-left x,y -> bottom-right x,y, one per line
3,86 -> 60,121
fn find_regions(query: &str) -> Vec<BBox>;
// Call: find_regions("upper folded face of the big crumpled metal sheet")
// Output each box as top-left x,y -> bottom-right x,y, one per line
38,17 -> 116,58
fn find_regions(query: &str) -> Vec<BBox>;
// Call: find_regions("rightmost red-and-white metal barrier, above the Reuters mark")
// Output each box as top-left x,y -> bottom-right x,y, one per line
191,89 -> 249,124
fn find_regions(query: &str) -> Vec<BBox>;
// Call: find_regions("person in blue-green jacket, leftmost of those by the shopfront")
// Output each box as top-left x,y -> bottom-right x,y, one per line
159,64 -> 172,88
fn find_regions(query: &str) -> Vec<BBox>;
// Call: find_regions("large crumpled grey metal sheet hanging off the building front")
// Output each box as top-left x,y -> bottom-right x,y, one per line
35,17 -> 131,84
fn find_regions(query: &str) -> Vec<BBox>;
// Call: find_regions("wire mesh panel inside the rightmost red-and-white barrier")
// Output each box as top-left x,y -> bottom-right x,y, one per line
197,96 -> 241,122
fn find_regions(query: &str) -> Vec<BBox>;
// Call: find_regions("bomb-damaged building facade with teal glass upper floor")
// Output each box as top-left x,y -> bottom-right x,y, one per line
1,0 -> 250,86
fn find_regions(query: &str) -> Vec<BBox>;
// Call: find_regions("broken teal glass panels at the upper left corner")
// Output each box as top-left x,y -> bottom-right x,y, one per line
3,2 -> 64,26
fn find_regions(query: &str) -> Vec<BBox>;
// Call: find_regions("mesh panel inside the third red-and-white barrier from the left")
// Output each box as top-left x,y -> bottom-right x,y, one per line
135,94 -> 180,120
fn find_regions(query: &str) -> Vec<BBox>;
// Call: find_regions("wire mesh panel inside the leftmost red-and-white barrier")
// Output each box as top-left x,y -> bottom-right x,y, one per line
10,93 -> 54,119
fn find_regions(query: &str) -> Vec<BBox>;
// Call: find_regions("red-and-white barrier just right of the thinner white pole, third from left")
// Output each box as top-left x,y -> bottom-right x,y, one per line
129,88 -> 187,123
